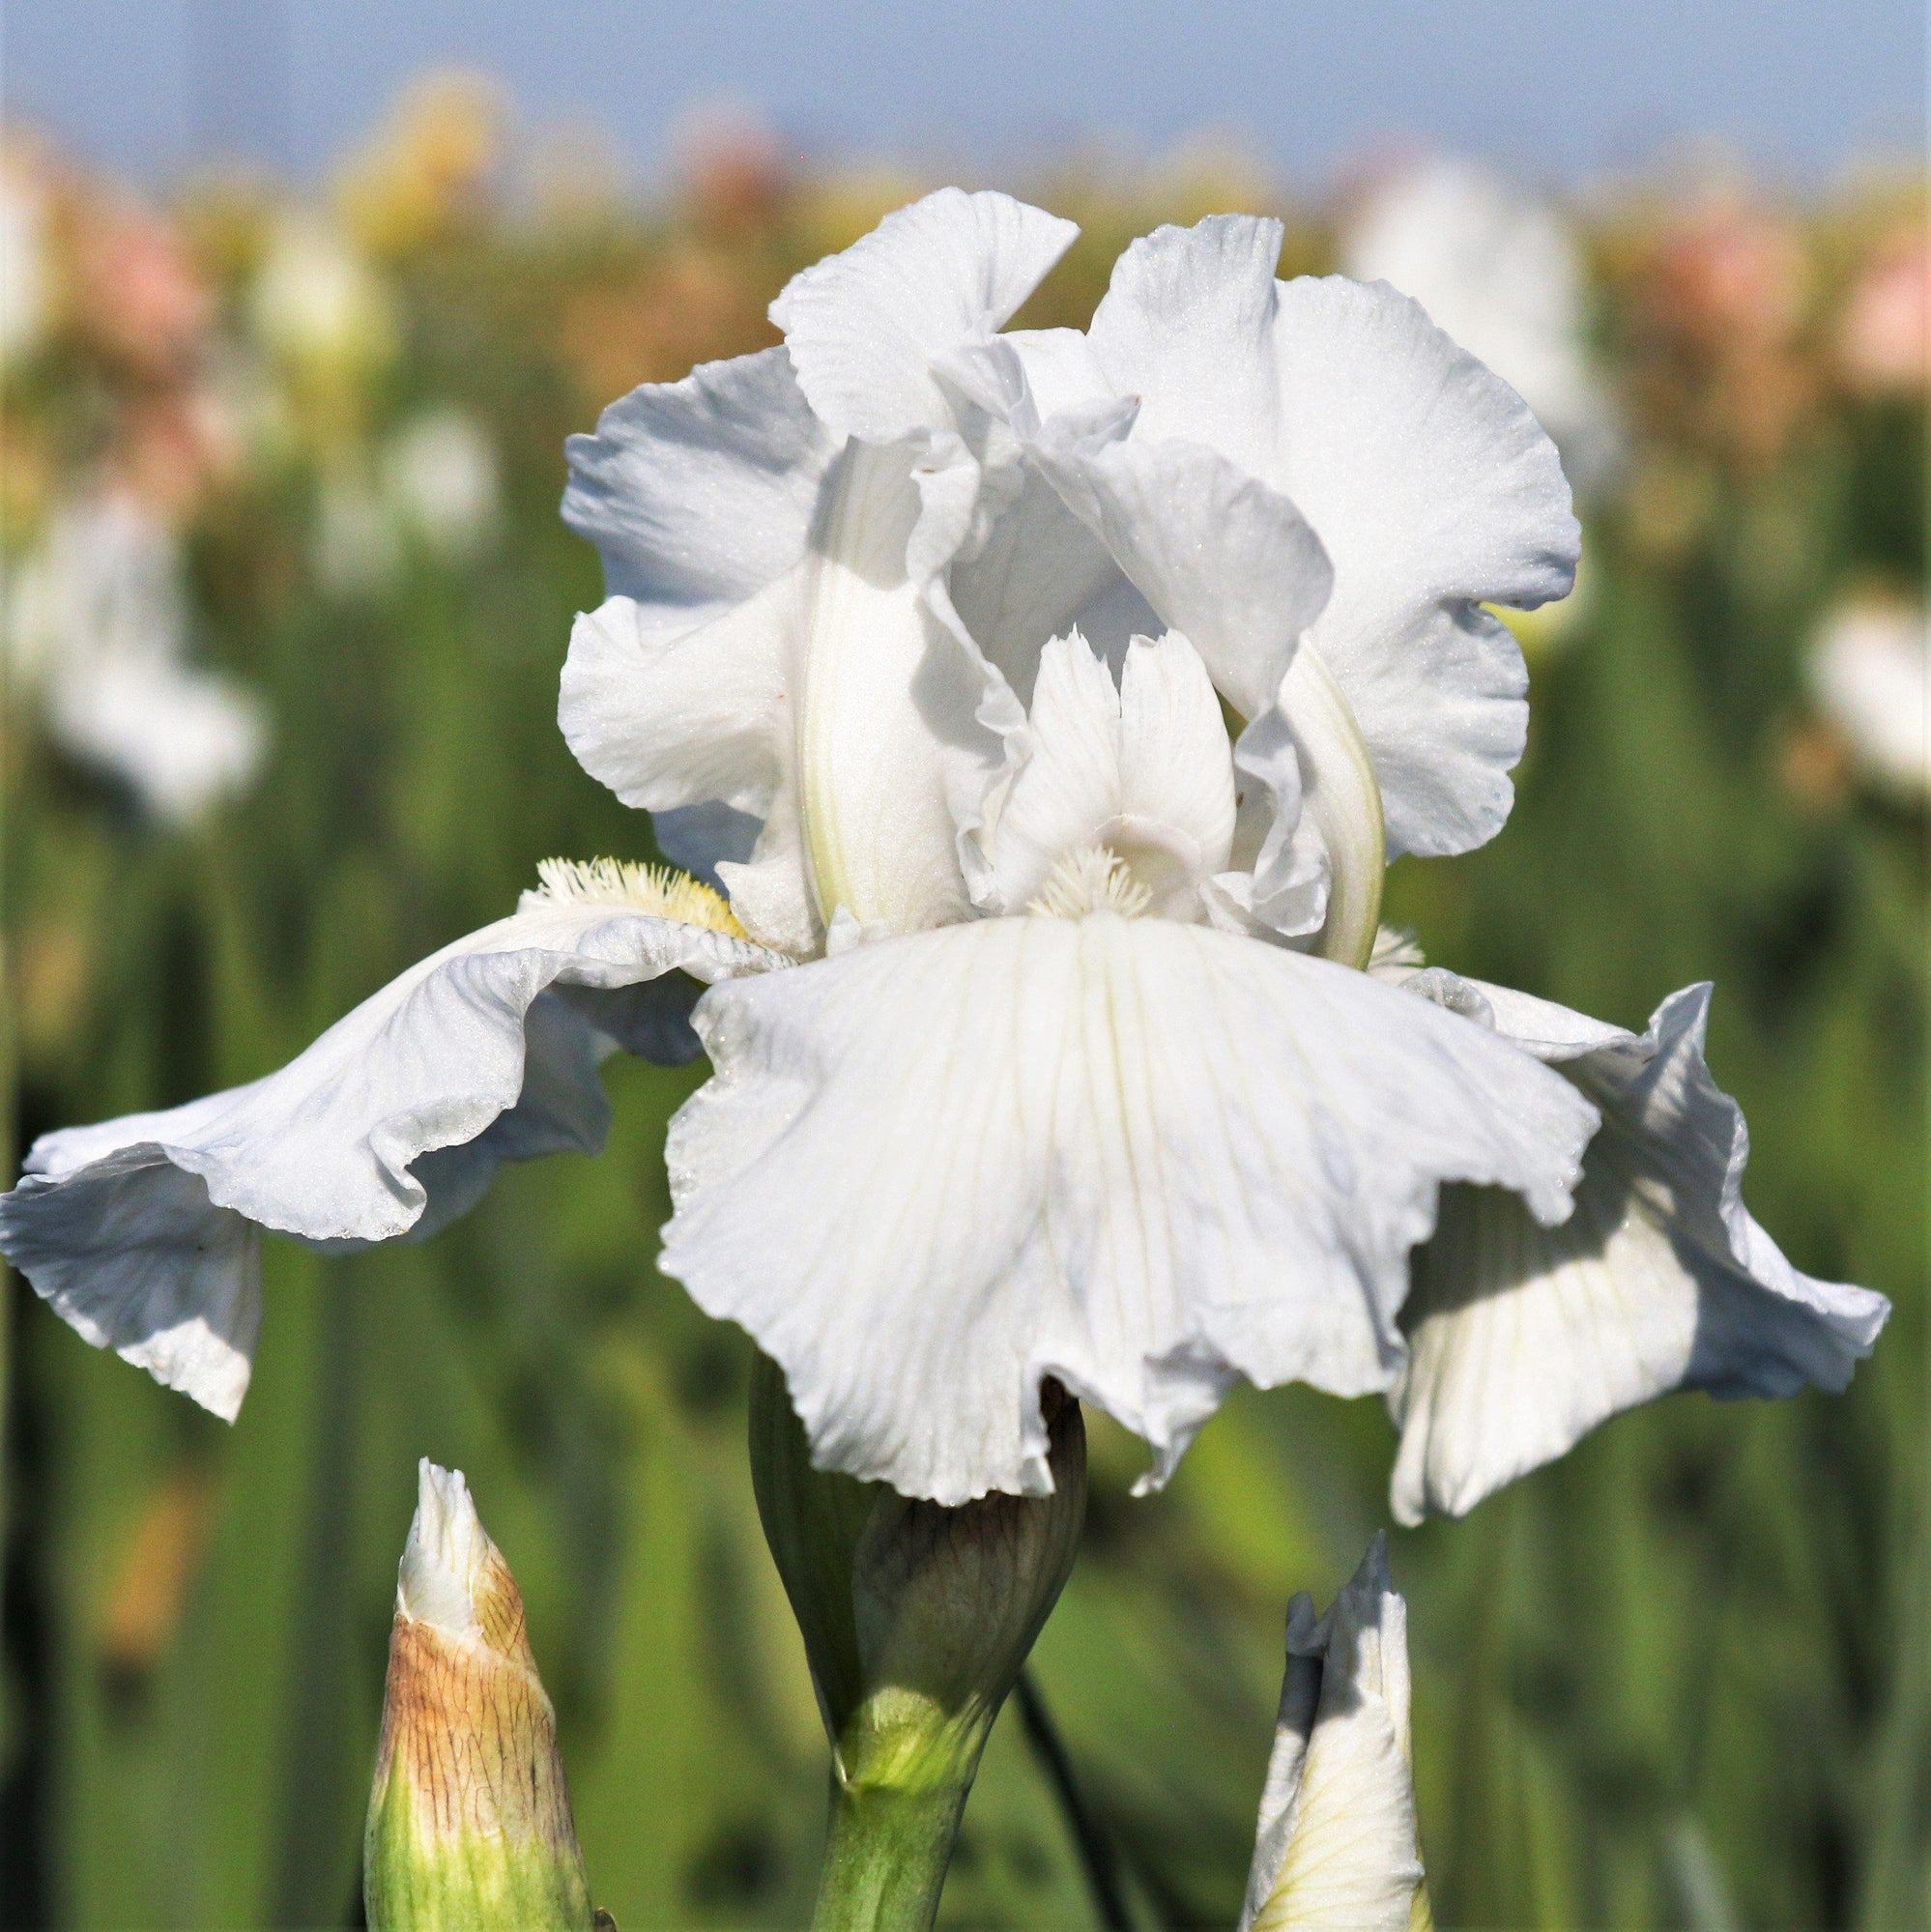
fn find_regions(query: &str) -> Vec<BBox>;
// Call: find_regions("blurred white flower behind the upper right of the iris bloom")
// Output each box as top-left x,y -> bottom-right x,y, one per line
1341,159 -> 1620,489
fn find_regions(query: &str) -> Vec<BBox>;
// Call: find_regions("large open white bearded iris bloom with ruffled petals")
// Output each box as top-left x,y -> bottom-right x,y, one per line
0,189 -> 1885,1514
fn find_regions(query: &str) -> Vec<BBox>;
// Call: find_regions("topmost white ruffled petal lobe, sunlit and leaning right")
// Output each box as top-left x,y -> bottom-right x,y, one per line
771,187 -> 1079,443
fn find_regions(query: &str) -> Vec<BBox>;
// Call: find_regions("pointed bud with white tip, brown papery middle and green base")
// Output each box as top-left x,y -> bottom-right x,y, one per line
363,1458 -> 609,1932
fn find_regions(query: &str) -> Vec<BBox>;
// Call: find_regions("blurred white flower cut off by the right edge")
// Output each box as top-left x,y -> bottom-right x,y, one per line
1807,597 -> 1931,800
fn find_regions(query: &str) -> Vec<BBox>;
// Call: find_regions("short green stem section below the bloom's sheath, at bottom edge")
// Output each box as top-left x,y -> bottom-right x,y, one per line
812,1773 -> 972,1932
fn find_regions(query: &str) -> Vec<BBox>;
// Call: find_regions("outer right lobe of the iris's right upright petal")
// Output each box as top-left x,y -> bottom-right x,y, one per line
1268,276 -> 1579,852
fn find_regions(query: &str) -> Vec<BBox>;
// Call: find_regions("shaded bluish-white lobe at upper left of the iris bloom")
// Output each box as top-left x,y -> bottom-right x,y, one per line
562,350 -> 841,606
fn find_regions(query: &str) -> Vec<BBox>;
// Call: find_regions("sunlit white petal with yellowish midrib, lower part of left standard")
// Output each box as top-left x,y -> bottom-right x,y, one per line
559,437 -> 1019,953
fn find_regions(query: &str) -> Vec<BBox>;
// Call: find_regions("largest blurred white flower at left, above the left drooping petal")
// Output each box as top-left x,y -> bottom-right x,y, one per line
6,491 -> 269,825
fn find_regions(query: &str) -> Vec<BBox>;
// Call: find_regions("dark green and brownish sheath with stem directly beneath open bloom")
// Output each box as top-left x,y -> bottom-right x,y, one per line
752,1356 -> 1086,1926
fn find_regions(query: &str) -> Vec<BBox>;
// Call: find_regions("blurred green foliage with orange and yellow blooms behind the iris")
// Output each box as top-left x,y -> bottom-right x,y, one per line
0,78 -> 1931,1932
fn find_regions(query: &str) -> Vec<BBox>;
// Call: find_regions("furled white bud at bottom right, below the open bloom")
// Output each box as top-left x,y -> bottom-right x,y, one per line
1241,1536 -> 1432,1932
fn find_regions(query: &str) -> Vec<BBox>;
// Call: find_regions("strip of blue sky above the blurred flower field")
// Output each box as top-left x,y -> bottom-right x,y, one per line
0,0 -> 1925,182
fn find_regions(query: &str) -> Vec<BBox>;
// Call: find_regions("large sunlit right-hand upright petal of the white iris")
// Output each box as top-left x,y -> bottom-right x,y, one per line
1061,216 -> 1579,852
